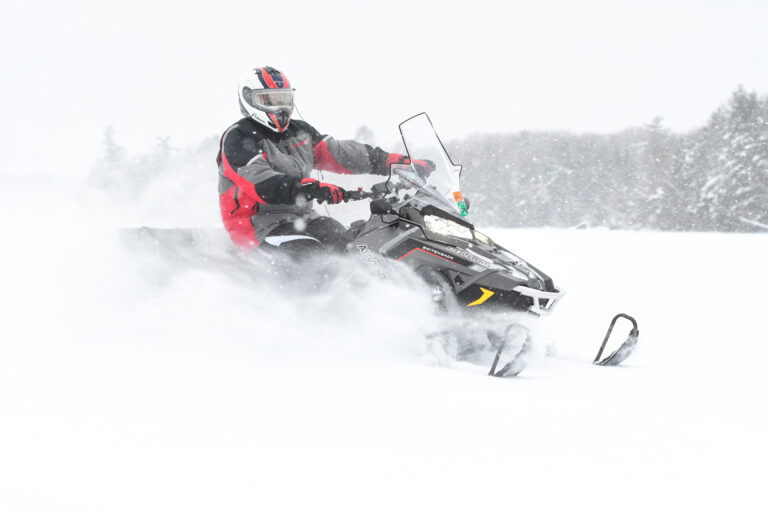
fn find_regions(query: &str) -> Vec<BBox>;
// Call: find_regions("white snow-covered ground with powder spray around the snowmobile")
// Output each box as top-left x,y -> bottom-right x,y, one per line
0,179 -> 768,512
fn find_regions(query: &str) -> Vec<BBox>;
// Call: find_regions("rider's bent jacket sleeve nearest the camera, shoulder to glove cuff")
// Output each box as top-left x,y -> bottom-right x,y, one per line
218,123 -> 301,204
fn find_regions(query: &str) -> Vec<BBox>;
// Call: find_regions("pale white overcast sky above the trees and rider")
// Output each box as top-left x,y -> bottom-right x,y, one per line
0,0 -> 768,172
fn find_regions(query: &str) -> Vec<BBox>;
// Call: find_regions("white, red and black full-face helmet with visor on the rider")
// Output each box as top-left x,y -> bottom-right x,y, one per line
237,66 -> 294,133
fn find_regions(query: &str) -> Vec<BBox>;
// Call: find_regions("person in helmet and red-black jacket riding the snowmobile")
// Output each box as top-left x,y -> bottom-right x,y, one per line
216,66 -> 435,254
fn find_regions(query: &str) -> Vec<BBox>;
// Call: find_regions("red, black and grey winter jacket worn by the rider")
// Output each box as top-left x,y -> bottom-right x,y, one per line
216,117 -> 392,248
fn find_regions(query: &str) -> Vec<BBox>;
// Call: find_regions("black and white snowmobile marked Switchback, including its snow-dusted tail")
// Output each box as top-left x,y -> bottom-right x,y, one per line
123,113 -> 639,377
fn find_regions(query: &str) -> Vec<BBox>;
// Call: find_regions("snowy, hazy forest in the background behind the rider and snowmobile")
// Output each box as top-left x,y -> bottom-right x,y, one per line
91,87 -> 768,231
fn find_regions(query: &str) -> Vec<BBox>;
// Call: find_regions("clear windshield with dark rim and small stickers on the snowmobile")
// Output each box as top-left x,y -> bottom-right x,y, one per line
392,113 -> 469,222
